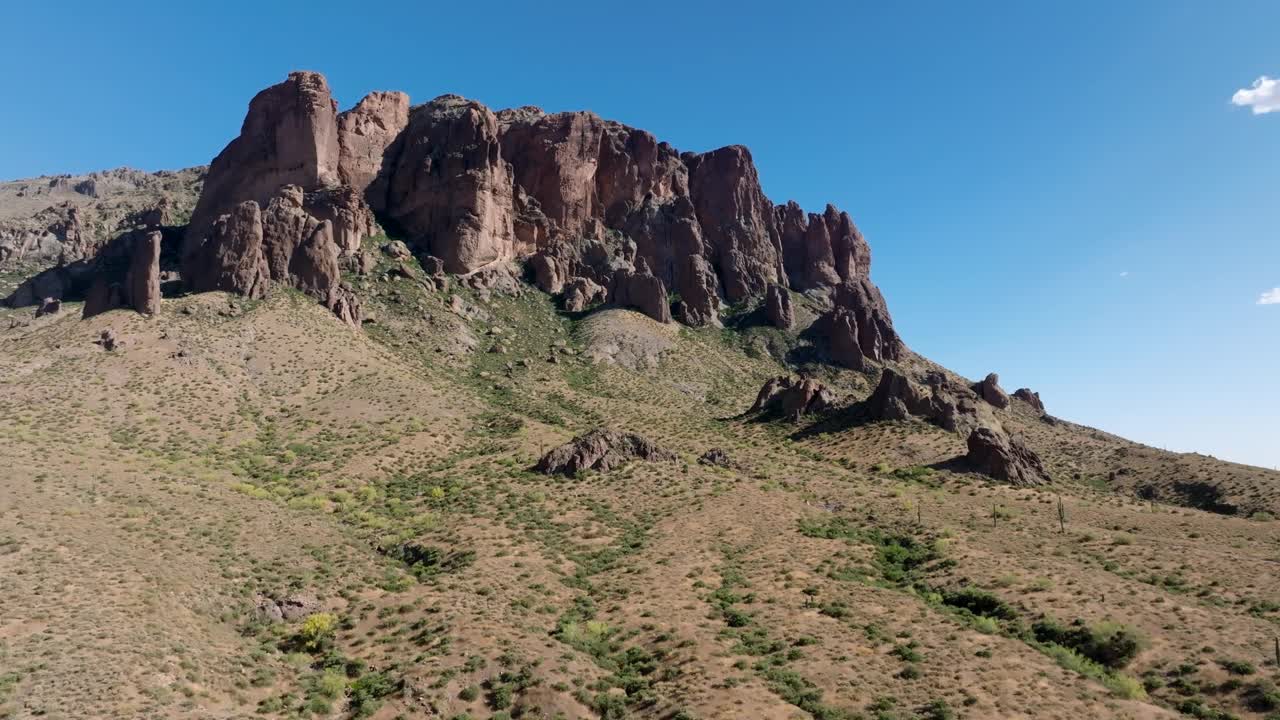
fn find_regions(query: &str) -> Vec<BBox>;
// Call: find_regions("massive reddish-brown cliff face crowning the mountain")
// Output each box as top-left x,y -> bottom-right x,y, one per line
172,72 -> 902,348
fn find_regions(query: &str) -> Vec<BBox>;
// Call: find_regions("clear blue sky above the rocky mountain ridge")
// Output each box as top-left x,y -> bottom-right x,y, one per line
0,0 -> 1280,466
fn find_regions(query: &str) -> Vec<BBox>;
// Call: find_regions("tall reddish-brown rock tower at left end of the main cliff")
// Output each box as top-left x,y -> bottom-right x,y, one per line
182,72 -> 378,325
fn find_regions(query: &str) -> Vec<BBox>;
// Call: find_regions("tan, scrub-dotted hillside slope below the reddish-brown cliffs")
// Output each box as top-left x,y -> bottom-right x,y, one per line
0,255 -> 1280,719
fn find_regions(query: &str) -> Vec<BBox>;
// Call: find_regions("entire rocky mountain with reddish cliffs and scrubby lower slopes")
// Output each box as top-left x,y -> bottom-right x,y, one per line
0,72 -> 1280,720
